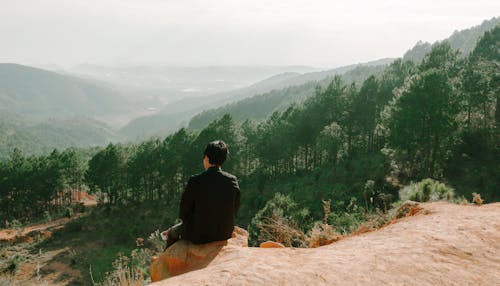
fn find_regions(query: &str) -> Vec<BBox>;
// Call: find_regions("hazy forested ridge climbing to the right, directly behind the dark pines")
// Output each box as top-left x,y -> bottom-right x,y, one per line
189,18 -> 500,129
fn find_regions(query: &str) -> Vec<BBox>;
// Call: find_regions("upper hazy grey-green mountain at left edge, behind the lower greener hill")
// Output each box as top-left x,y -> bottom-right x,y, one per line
0,63 -> 130,123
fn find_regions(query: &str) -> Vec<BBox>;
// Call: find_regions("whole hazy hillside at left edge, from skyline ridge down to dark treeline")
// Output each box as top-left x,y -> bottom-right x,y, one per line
0,63 -> 131,159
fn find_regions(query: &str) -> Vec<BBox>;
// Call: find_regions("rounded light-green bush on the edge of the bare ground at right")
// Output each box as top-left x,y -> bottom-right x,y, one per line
399,179 -> 455,202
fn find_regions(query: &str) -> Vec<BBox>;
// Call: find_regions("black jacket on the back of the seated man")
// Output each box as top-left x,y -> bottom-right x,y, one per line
179,167 -> 240,244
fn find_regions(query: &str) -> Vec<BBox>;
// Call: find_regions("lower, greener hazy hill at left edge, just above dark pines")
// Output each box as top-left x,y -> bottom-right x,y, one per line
0,112 -> 121,159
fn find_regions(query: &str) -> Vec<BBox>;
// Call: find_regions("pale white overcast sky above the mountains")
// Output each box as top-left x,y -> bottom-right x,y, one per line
0,0 -> 500,67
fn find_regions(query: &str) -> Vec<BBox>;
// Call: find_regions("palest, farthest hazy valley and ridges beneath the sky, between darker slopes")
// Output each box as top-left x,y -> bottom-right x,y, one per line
66,64 -> 316,105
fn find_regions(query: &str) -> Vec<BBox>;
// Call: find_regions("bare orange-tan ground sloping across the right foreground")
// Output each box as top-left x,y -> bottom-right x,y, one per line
153,202 -> 500,286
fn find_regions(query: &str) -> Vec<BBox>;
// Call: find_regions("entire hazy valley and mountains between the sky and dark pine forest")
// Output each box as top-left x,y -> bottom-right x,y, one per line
0,15 -> 499,157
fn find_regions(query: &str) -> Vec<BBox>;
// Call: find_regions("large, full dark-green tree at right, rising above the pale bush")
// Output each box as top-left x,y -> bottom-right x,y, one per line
388,44 -> 459,178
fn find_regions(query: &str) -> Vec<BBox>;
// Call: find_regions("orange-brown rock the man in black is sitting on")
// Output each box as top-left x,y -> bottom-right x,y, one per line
150,226 -> 248,282
